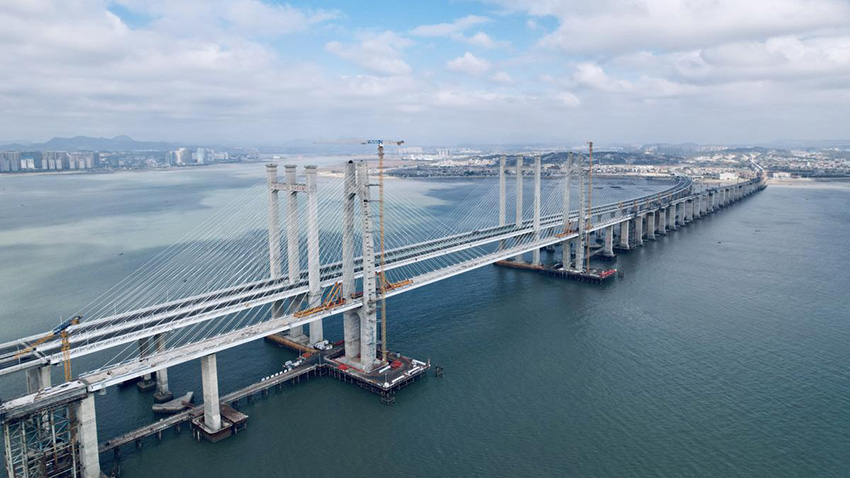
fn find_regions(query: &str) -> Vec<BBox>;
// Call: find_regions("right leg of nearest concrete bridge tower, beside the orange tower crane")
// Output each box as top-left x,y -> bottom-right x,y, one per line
357,162 -> 378,371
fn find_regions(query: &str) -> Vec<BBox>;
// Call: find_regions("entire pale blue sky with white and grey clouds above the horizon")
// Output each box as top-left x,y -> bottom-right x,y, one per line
0,0 -> 850,144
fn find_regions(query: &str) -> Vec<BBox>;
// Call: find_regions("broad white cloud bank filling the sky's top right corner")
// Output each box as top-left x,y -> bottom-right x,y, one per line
497,0 -> 850,54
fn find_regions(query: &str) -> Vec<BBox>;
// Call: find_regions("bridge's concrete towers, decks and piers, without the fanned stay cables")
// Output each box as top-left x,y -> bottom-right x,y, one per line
0,156 -> 765,477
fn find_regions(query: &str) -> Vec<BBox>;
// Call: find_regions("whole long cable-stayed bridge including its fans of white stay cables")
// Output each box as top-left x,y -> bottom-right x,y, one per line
0,156 -> 764,476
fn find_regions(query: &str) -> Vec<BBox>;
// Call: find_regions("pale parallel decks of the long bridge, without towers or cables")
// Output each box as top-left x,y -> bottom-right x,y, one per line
0,179 -> 763,417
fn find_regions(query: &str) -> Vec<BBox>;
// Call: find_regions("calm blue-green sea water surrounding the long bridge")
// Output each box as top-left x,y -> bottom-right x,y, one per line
0,165 -> 850,478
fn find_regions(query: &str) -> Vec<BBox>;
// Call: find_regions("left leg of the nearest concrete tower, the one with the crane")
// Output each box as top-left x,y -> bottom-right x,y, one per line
342,161 -> 360,361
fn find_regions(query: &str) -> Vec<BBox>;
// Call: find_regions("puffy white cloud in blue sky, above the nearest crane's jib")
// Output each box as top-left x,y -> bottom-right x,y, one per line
325,31 -> 413,75
